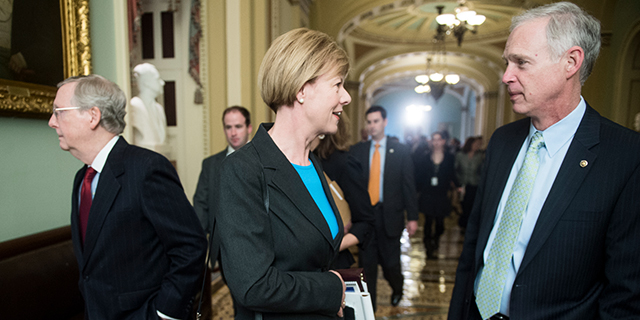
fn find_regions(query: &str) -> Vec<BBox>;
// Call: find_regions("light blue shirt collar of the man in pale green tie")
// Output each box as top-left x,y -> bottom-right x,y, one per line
529,96 -> 587,157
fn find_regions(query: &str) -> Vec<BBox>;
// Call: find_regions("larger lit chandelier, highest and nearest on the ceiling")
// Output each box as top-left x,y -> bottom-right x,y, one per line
435,0 -> 487,47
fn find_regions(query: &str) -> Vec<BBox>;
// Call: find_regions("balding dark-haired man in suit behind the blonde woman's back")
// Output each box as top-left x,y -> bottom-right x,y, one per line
193,106 -> 253,235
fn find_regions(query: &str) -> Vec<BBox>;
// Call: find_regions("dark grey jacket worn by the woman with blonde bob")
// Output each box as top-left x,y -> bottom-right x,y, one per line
215,124 -> 344,320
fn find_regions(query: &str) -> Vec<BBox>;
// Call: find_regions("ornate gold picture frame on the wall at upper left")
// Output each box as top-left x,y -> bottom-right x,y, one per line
0,0 -> 91,119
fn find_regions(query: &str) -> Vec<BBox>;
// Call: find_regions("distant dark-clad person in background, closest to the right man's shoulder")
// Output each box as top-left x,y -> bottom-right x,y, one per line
455,137 -> 484,232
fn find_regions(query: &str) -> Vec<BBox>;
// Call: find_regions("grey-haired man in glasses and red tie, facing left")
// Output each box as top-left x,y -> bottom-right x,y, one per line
49,75 -> 206,320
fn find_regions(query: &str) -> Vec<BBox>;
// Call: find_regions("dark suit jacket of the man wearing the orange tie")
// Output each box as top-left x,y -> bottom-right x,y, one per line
349,138 -> 418,237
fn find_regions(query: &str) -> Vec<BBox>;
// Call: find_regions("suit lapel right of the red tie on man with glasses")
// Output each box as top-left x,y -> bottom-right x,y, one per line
83,138 -> 128,264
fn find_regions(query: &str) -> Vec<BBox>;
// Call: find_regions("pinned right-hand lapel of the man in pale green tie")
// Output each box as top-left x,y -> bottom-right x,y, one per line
518,105 -> 600,273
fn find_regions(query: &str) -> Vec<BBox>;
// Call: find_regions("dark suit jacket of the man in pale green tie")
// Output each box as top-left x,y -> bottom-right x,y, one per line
449,106 -> 640,320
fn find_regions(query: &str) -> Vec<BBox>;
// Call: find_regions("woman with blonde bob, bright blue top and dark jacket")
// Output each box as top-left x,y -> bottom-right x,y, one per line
215,29 -> 351,320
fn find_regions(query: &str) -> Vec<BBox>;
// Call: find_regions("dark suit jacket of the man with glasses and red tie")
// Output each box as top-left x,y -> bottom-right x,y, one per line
71,137 -> 206,320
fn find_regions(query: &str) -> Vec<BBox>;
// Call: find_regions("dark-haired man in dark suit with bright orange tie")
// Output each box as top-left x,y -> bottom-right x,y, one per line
349,106 -> 418,309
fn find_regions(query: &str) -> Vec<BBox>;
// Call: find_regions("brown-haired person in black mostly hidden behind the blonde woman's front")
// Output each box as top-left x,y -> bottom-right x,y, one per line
313,113 -> 375,269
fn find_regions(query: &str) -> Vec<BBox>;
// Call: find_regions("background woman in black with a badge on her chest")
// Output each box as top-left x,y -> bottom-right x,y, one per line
416,132 -> 457,259
